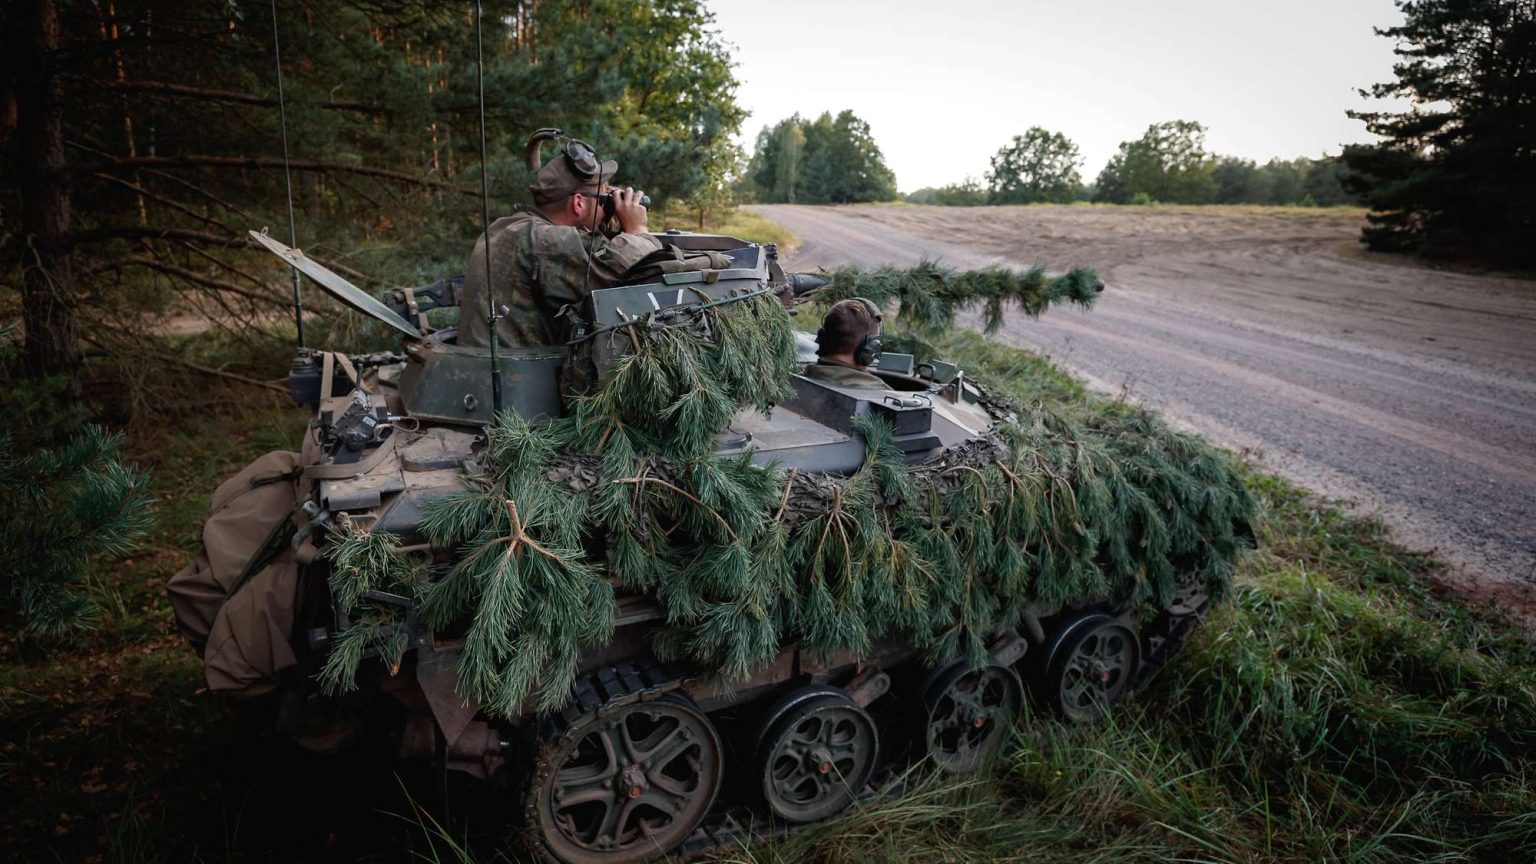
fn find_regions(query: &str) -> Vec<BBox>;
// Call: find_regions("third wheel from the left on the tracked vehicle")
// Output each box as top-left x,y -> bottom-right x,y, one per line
923,660 -> 1025,775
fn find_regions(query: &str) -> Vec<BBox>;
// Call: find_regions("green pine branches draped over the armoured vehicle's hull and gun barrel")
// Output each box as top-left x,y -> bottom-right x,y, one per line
324,268 -> 1253,716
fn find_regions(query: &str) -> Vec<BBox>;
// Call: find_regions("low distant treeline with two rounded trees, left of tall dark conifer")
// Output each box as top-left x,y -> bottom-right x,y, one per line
906,120 -> 1356,206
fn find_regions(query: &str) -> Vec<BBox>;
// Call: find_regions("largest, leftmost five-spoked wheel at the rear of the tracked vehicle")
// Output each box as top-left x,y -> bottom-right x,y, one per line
530,695 -> 722,864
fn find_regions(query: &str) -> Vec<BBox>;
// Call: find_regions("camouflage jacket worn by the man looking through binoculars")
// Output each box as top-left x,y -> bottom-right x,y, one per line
459,204 -> 662,347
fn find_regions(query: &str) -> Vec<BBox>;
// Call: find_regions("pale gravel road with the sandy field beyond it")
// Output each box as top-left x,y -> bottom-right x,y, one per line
754,206 -> 1536,612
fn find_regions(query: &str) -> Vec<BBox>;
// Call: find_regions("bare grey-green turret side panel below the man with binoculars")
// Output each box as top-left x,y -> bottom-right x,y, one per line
399,331 -> 565,426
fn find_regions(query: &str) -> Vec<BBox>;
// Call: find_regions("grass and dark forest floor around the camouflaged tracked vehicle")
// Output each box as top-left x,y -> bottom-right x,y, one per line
0,238 -> 1536,864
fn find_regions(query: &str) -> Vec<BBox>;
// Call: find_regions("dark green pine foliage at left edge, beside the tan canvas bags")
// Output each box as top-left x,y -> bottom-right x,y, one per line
0,426 -> 154,636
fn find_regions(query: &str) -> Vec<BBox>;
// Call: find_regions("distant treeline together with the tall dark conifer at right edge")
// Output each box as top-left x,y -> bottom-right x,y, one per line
908,0 -> 1536,268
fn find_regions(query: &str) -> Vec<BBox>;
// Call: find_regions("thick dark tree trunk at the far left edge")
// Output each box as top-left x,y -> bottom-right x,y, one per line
5,0 -> 80,384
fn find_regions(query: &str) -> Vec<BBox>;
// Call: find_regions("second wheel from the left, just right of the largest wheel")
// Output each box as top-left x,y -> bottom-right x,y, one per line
757,687 -> 880,822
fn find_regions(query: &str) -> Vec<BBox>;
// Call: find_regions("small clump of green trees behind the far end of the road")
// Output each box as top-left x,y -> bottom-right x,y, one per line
739,111 -> 897,204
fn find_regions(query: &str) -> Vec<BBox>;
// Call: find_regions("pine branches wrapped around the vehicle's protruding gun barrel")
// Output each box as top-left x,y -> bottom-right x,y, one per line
813,261 -> 1103,335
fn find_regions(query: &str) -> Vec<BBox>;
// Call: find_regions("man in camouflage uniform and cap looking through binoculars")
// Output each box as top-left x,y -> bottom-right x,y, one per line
459,129 -> 662,347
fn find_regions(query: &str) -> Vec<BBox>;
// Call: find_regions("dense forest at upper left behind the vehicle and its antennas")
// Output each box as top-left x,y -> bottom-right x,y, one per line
0,0 -> 745,390
